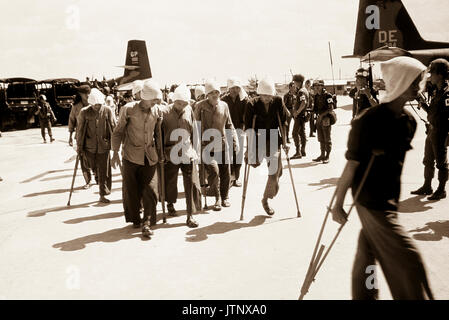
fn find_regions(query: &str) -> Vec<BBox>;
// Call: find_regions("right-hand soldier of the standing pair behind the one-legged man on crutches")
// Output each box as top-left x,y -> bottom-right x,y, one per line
313,79 -> 336,163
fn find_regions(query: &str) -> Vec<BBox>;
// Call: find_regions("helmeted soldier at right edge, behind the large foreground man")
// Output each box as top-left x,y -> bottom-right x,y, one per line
412,59 -> 449,200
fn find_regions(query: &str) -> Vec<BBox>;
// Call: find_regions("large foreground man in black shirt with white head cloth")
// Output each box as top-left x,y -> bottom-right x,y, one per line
332,57 -> 433,300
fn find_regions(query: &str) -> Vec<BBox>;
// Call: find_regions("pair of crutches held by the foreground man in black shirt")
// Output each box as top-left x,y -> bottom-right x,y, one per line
298,153 -> 378,300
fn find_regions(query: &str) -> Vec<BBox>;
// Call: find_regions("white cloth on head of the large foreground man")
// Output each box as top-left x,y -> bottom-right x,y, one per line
380,57 -> 426,103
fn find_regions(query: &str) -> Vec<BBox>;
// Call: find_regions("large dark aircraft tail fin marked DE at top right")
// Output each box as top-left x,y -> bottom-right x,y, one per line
353,0 -> 449,57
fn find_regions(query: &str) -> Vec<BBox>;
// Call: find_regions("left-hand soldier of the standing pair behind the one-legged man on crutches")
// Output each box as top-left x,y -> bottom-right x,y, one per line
292,74 -> 309,159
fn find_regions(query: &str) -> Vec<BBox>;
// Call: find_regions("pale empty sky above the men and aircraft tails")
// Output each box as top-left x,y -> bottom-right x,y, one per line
0,0 -> 449,85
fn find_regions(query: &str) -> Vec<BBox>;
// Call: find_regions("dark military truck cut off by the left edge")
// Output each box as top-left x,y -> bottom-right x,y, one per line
0,78 -> 37,131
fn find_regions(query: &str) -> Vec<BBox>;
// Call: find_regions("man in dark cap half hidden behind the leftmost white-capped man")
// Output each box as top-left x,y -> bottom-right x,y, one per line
69,84 -> 93,189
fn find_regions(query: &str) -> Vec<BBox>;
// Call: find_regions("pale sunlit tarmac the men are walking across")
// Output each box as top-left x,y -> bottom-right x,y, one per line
0,97 -> 449,300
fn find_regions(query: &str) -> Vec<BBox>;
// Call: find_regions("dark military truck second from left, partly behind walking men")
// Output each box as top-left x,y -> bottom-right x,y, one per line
37,78 -> 80,125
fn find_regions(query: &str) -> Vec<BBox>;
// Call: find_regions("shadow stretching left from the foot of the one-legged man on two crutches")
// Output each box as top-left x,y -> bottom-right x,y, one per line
186,216 -> 271,242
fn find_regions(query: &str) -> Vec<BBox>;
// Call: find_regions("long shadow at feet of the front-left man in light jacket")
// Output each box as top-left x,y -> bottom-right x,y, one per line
53,226 -> 146,251
